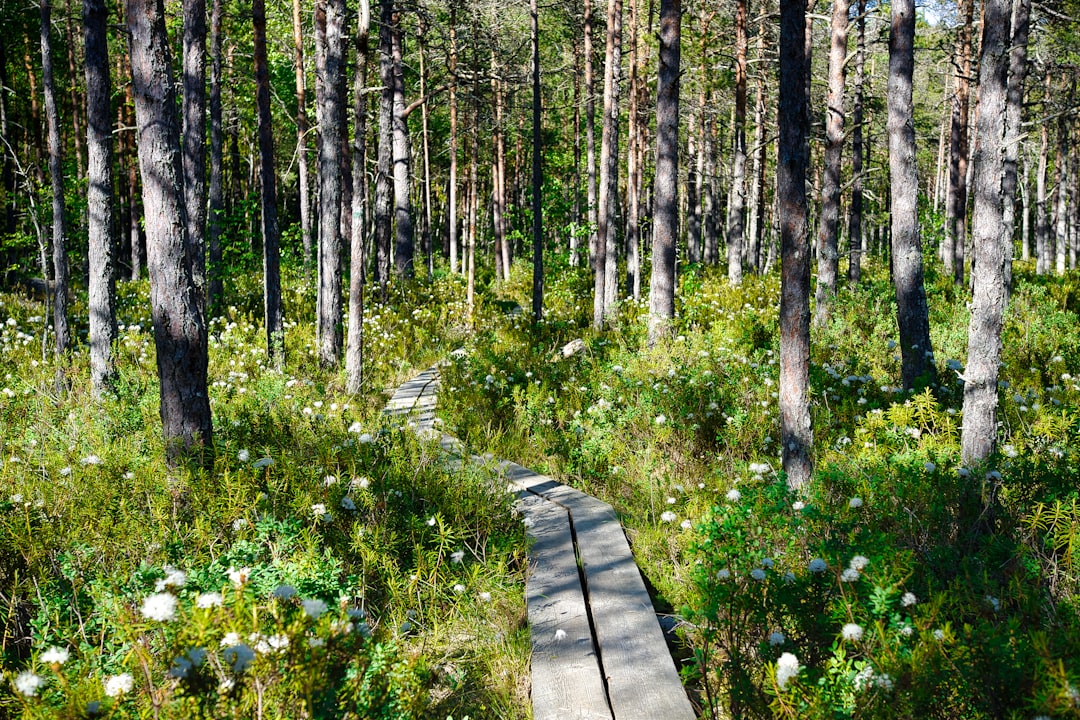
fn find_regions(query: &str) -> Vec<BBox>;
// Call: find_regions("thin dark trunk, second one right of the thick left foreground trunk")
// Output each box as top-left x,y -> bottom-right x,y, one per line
206,0 -> 225,314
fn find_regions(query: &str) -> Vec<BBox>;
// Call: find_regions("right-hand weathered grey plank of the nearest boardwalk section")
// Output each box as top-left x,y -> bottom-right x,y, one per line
571,511 -> 696,720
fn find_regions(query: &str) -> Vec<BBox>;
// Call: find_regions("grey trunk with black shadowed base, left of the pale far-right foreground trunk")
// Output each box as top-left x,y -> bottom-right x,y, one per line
888,0 -> 934,389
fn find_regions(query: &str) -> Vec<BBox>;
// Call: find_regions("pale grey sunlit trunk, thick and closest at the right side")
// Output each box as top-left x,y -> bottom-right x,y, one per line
960,0 -> 1011,465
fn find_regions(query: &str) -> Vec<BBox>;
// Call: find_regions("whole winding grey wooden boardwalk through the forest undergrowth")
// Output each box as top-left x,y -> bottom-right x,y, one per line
384,366 -> 697,720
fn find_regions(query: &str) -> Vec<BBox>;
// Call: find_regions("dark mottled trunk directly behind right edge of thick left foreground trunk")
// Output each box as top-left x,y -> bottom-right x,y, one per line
184,0 -> 206,312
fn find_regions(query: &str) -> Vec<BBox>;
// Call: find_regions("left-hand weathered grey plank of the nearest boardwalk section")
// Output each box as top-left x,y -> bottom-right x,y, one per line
518,495 -> 611,720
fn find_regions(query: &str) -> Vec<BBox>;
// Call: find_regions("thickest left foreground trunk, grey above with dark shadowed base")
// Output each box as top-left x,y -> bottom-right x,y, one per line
125,0 -> 214,467
